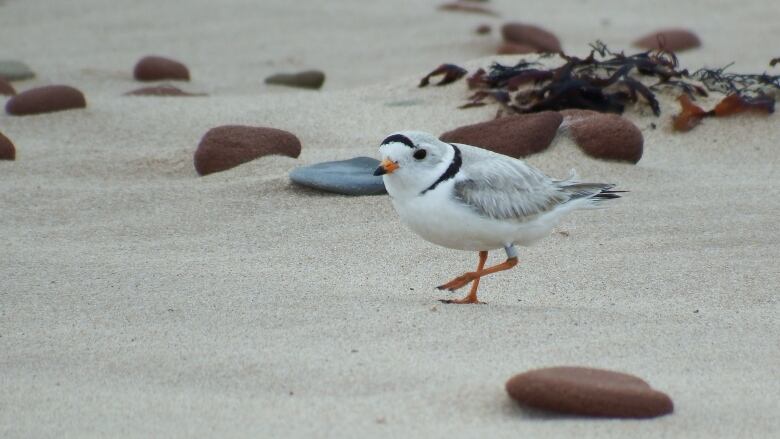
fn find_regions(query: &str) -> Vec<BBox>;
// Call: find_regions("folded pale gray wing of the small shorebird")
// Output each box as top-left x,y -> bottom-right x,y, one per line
454,147 -> 574,221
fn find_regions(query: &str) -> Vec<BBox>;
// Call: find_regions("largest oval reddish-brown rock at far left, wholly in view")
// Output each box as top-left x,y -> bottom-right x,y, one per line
5,85 -> 87,116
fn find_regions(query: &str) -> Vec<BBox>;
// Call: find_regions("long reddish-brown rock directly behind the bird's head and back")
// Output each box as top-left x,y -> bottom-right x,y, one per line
440,111 -> 563,158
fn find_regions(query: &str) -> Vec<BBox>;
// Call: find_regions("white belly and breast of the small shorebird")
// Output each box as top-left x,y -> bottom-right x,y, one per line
392,184 -> 557,251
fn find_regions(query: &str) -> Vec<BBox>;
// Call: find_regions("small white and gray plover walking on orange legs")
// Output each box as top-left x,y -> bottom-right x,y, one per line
374,131 -> 626,304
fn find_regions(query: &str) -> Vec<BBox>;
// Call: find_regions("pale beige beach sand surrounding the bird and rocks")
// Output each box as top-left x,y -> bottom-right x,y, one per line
0,0 -> 780,438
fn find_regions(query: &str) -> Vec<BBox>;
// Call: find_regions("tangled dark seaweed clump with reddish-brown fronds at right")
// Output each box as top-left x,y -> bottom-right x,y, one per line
421,41 -> 780,131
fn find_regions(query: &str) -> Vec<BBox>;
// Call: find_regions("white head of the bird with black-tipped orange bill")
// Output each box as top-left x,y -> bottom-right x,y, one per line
374,131 -> 452,184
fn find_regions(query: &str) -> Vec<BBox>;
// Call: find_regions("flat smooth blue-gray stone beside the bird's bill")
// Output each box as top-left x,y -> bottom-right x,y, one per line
290,157 -> 387,195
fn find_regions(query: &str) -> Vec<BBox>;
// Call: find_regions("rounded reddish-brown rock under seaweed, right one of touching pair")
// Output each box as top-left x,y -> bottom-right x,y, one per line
561,110 -> 645,163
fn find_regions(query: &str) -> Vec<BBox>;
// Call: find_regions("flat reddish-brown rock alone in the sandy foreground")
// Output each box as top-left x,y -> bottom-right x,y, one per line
506,367 -> 674,418
